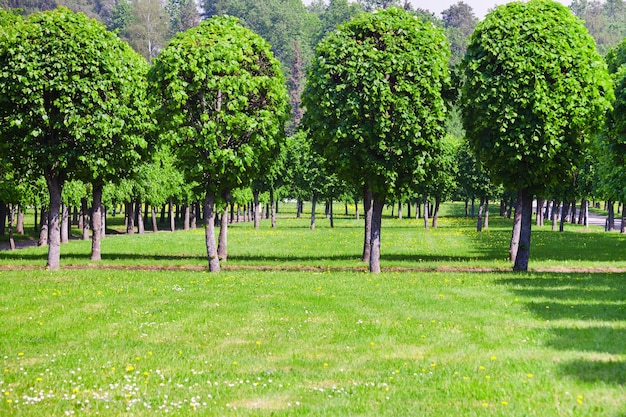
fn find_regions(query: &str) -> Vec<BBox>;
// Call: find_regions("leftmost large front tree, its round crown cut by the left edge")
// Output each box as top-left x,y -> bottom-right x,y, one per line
0,8 -> 150,269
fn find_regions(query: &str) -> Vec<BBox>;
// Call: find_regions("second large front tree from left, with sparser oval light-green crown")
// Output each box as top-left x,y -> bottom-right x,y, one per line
150,17 -> 289,271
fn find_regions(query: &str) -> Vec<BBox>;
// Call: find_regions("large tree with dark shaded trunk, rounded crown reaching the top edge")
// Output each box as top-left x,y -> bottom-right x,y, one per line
461,0 -> 613,271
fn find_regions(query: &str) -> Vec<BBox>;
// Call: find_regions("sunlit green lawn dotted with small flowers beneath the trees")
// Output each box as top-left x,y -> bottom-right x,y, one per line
0,202 -> 626,417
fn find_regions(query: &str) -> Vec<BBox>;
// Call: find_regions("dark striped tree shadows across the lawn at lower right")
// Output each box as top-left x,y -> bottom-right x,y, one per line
499,273 -> 626,385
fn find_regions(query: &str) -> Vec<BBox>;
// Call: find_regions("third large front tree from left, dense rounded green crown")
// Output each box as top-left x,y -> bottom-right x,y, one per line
302,8 -> 449,272
